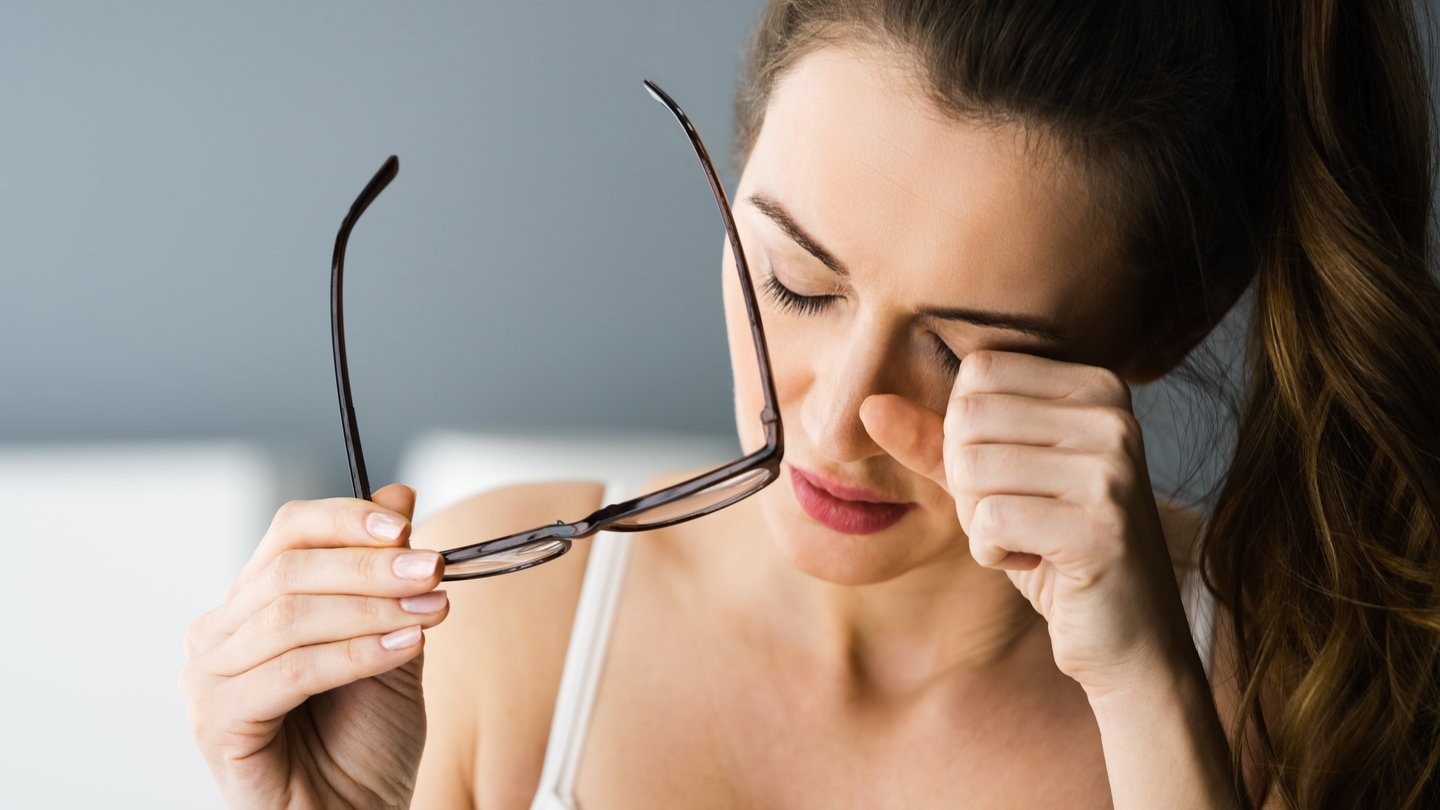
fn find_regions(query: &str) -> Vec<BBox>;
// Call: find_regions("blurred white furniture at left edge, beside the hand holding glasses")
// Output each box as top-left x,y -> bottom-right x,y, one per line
0,444 -> 318,810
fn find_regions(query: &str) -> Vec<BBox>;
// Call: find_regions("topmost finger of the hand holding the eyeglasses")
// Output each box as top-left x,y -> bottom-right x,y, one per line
229,484 -> 415,597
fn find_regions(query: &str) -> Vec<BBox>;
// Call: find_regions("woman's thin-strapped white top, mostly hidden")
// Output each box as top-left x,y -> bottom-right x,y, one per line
530,510 -> 1215,810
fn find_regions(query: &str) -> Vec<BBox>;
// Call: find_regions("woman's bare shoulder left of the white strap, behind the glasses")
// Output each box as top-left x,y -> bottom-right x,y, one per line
413,481 -> 603,807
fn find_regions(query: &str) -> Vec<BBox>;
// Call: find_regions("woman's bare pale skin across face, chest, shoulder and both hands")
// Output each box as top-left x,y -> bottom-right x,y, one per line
181,46 -> 1234,810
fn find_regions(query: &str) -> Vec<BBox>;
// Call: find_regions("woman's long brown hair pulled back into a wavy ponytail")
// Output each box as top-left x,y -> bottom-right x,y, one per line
736,0 -> 1440,807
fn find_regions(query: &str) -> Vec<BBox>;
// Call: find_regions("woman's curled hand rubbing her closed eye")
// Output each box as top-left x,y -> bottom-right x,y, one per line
861,352 -> 1195,696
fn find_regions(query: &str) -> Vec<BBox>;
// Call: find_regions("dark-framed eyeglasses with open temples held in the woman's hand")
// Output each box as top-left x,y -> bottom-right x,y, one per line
330,79 -> 785,581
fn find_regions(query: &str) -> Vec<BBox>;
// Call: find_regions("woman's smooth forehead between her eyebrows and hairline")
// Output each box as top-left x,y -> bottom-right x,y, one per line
739,46 -> 1122,324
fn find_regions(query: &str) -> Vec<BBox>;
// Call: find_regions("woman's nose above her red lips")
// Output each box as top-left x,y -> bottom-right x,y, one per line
801,318 -> 897,464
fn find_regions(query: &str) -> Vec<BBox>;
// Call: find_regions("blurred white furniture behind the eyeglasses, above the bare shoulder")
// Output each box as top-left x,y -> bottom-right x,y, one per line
397,430 -> 740,520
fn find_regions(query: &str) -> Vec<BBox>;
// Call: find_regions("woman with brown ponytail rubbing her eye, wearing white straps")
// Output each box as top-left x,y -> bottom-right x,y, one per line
181,0 -> 1440,809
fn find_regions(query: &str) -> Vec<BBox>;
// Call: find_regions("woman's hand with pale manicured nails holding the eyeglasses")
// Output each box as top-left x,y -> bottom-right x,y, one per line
180,486 -> 449,809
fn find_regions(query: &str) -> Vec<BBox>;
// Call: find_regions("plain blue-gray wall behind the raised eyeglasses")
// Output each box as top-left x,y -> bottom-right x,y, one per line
0,0 -> 759,487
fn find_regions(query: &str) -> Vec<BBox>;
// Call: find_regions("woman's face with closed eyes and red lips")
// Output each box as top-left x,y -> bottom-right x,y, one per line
724,48 -> 1132,584
